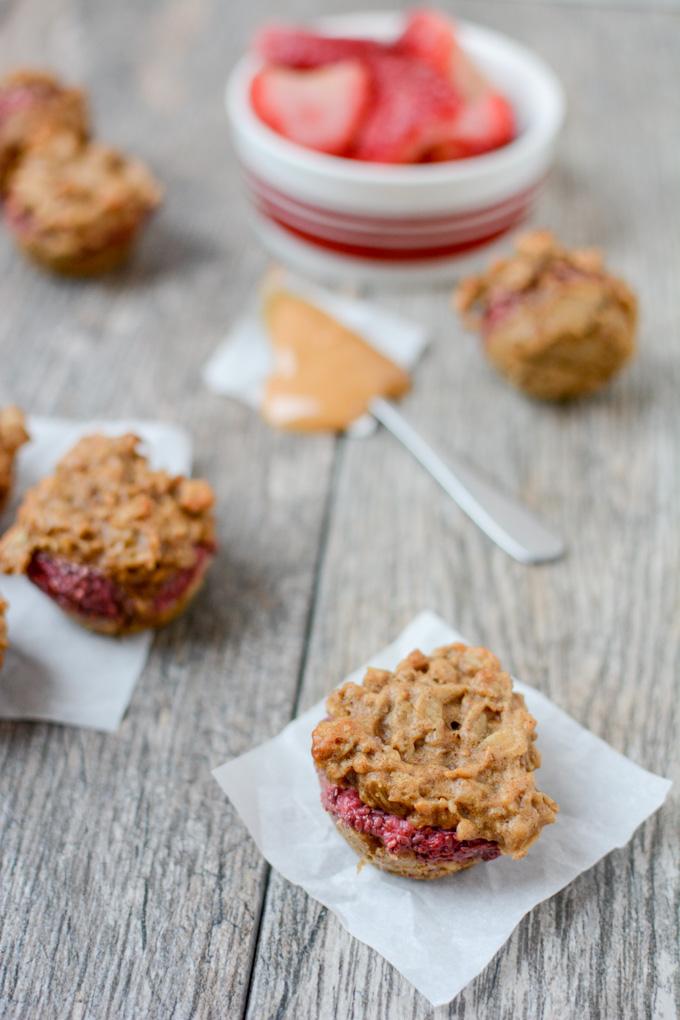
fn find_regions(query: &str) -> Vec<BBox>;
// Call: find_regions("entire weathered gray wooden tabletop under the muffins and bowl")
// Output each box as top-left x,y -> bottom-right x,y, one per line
0,0 -> 680,1020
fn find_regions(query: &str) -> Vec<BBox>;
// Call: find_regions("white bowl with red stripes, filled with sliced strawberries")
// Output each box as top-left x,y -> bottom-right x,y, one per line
226,11 -> 565,282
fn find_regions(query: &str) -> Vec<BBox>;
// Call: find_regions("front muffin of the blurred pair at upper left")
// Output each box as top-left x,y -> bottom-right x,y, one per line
5,135 -> 162,276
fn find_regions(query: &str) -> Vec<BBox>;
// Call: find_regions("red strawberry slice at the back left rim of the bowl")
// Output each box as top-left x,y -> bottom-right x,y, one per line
255,24 -> 385,69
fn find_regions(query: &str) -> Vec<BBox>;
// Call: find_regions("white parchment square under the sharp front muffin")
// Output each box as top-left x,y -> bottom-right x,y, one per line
214,612 -> 671,1006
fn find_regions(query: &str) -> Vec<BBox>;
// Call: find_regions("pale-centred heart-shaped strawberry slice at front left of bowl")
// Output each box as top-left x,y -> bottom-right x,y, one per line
251,60 -> 370,156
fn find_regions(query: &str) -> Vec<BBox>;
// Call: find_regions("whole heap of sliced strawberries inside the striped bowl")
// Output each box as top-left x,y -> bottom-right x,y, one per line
244,10 -> 515,164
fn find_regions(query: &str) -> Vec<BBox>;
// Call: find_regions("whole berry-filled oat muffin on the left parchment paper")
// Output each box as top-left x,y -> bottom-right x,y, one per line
0,435 -> 215,634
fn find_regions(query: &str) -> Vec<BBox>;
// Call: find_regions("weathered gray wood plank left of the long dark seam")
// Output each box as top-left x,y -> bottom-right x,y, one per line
0,0 -> 333,1020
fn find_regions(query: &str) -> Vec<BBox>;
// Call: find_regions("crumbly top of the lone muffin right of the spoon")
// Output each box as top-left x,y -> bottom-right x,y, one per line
454,231 -> 636,329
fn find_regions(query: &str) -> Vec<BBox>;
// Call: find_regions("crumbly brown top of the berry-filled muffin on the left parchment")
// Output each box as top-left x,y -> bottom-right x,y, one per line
0,434 -> 215,585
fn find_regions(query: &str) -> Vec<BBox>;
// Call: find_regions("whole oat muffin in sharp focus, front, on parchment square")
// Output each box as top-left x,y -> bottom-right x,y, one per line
312,644 -> 558,879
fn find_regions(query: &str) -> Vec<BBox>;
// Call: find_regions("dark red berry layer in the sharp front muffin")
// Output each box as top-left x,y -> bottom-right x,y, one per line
321,778 -> 501,864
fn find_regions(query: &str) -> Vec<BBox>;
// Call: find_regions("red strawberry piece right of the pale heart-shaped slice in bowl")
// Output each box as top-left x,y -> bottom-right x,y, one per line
353,53 -> 461,163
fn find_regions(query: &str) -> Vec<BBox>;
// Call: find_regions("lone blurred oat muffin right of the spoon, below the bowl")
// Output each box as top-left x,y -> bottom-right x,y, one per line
455,231 -> 637,400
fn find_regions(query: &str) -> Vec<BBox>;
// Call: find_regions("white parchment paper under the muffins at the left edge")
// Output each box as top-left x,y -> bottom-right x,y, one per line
0,417 -> 192,731
